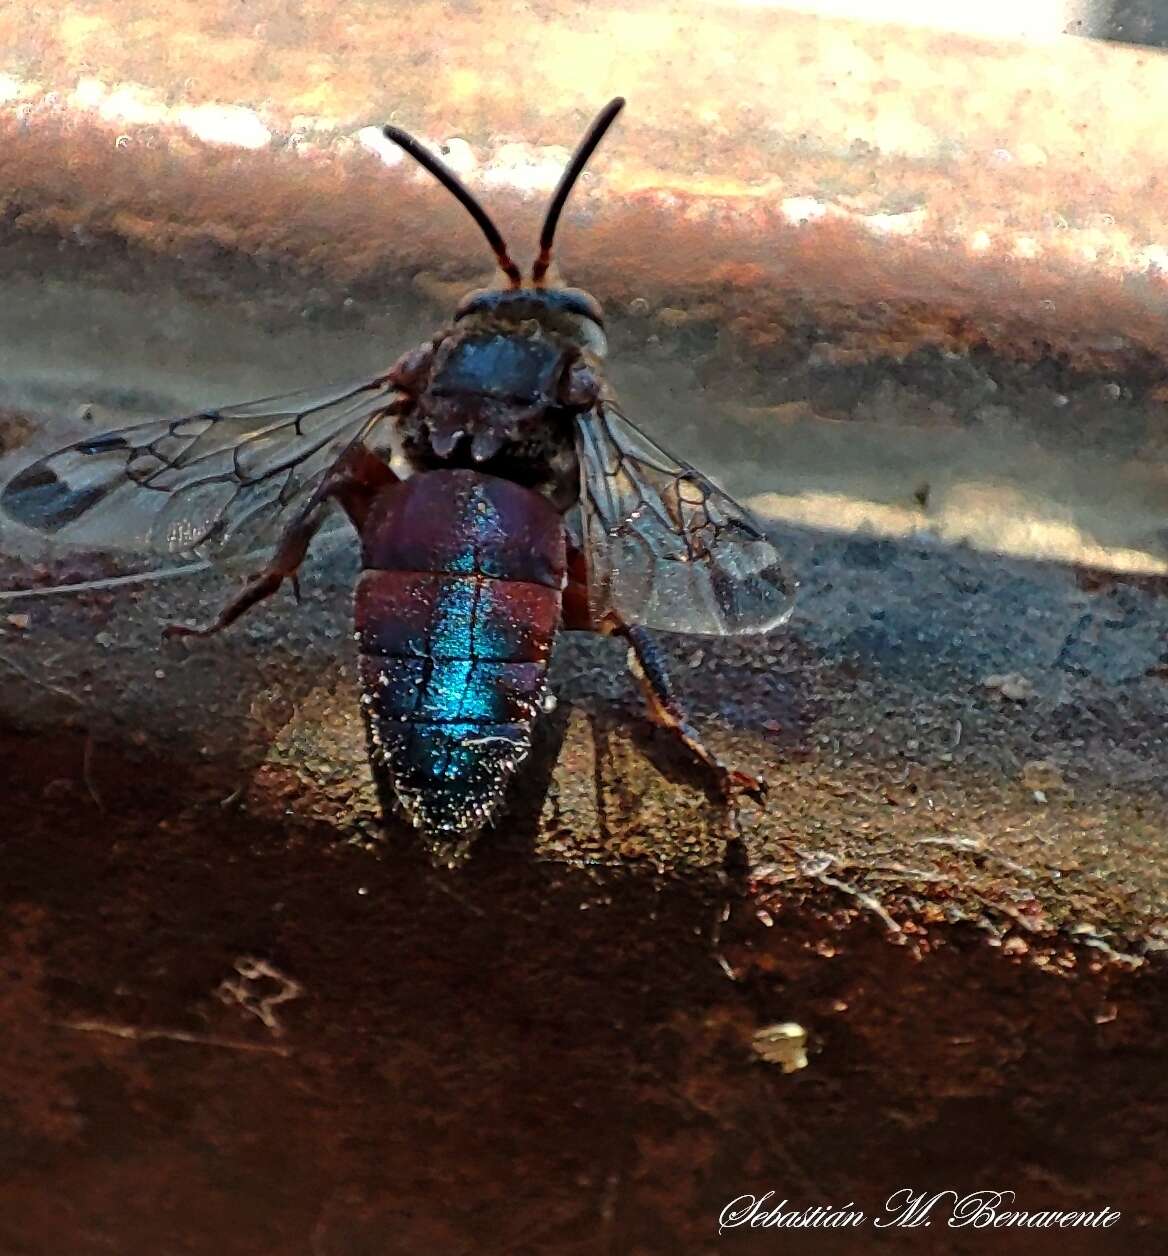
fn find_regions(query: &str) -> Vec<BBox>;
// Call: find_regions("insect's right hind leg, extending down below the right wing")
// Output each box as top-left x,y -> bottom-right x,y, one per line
564,550 -> 766,801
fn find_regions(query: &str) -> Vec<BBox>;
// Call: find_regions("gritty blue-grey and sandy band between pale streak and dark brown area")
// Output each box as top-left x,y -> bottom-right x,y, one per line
0,509 -> 1168,956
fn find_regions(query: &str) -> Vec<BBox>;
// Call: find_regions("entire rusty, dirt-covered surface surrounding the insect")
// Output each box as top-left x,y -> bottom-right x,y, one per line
0,9 -> 1168,1240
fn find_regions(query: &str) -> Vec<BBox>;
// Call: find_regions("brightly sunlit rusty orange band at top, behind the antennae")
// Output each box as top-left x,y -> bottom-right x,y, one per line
0,0 -> 1168,363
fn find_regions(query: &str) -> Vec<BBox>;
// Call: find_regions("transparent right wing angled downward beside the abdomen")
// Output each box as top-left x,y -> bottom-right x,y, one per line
576,401 -> 795,636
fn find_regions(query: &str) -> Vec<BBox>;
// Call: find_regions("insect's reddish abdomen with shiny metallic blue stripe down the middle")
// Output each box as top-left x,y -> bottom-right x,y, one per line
355,471 -> 565,831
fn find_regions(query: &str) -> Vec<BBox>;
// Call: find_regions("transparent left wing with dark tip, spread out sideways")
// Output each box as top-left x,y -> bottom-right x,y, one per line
0,377 -> 398,560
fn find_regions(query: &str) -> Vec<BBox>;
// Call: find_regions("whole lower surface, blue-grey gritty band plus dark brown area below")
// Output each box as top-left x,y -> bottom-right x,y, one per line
0,502 -> 1168,1256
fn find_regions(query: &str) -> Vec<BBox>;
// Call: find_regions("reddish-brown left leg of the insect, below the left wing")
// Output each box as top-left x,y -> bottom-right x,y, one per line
162,445 -> 398,637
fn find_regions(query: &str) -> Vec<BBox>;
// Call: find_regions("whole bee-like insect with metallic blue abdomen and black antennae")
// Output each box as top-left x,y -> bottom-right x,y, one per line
0,98 -> 792,834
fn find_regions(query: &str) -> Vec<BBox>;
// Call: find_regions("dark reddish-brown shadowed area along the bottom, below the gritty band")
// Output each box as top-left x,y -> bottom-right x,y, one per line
0,763 -> 1168,1256
